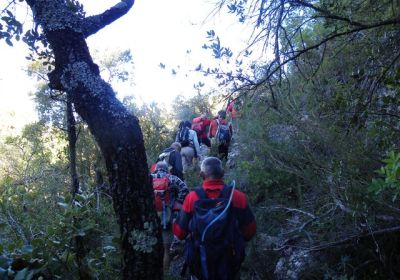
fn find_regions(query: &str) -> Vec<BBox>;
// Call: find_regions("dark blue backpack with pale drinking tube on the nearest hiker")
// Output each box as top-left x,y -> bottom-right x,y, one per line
185,182 -> 245,280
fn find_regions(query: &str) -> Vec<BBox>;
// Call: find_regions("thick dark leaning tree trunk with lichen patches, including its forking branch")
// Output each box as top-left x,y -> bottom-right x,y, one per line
26,0 -> 163,279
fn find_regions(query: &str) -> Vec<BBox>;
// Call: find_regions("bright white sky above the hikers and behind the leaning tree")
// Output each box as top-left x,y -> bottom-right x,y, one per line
0,0 -> 262,132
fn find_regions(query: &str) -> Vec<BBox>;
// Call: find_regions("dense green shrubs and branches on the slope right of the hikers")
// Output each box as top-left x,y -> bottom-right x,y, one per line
214,1 -> 400,279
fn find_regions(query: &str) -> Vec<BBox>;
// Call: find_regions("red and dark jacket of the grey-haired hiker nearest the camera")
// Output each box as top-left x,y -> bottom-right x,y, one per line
172,180 -> 256,240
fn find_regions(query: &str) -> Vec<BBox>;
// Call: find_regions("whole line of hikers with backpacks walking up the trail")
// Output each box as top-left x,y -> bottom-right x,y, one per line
151,106 -> 256,280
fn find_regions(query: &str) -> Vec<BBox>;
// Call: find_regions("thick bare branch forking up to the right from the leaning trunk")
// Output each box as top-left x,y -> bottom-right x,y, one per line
82,0 -> 135,38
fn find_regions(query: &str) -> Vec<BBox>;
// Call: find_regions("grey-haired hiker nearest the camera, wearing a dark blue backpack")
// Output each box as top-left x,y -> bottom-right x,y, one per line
172,157 -> 256,280
